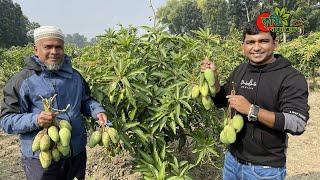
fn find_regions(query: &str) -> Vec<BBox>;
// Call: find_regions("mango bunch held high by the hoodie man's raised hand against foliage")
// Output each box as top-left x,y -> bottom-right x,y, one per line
191,64 -> 216,110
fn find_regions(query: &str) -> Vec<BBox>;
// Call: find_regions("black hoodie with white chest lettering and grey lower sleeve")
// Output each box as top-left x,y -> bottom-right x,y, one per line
213,54 -> 309,167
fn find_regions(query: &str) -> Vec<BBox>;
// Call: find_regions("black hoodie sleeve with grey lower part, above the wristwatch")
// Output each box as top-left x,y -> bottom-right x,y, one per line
274,73 -> 309,135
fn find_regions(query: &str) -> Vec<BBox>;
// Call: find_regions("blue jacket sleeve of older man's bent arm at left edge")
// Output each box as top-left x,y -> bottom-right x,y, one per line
0,78 -> 40,134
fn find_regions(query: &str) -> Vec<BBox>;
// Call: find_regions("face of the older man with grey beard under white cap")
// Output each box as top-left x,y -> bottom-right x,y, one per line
34,38 -> 64,70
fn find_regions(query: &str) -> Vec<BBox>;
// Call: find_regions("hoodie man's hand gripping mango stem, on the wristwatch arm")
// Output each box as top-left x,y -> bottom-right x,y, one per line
227,95 -> 251,114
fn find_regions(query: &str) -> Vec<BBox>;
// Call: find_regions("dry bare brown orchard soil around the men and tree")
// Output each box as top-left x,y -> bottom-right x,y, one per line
0,91 -> 320,180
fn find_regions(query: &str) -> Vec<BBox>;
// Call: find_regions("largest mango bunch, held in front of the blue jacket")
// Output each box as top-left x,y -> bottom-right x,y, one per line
32,96 -> 72,169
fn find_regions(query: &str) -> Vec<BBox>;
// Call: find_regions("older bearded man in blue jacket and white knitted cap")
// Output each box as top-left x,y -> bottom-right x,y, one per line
0,26 -> 107,180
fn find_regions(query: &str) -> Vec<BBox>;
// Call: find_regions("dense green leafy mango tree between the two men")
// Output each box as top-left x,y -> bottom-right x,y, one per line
74,27 -> 243,179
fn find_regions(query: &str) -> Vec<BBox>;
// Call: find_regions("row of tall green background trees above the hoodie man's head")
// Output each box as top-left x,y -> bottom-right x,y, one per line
157,0 -> 320,37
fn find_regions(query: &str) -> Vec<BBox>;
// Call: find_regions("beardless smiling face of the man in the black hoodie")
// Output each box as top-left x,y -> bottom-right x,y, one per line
242,32 -> 276,65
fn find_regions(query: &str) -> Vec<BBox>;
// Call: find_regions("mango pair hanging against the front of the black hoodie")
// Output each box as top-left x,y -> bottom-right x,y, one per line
220,114 -> 244,144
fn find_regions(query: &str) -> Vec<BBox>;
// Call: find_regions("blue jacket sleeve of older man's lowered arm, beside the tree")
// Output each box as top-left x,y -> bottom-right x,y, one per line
81,76 -> 105,118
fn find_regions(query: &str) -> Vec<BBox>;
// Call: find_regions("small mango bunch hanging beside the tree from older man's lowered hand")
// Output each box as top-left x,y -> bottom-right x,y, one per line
88,126 -> 120,148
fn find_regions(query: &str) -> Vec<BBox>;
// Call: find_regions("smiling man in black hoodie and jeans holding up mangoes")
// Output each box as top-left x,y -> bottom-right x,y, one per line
201,21 -> 309,180
